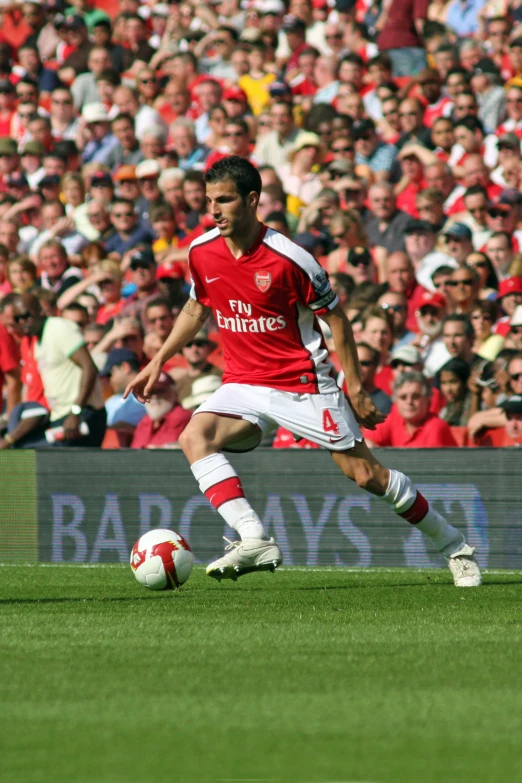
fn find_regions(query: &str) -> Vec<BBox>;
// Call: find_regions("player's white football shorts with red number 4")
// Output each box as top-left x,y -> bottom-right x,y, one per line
194,383 -> 363,451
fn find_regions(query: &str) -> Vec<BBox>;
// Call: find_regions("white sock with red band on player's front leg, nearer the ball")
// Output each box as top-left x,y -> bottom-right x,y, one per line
190,454 -> 268,539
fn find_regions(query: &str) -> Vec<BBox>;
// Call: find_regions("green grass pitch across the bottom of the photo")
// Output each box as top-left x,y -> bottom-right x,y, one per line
0,566 -> 522,783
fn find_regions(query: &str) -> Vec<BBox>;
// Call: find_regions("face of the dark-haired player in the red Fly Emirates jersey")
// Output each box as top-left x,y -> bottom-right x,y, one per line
207,179 -> 258,237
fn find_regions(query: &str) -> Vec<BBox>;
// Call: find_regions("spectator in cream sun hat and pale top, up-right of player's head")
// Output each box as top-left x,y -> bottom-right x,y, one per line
277,132 -> 327,217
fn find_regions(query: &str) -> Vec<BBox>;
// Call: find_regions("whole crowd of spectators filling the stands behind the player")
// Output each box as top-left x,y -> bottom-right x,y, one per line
0,0 -> 522,449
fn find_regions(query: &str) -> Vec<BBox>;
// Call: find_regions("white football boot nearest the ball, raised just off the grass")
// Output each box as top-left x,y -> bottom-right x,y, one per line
207,538 -> 283,582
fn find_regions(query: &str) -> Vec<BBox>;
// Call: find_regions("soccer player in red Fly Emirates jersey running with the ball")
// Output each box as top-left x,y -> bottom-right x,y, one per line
125,156 -> 481,587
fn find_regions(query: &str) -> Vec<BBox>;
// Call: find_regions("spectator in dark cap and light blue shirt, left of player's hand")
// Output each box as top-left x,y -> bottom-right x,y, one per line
100,348 -> 145,434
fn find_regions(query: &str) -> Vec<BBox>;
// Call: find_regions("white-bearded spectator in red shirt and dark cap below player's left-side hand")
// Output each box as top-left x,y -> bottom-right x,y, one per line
131,372 -> 192,449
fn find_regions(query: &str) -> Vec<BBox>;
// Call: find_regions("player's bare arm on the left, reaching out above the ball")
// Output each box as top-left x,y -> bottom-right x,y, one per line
123,298 -> 211,402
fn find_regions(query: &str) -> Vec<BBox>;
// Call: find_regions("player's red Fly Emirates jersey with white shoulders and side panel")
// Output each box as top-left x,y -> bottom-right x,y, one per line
189,226 -> 338,394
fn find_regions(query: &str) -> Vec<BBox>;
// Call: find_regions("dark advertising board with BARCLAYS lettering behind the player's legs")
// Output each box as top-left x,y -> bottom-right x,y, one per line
31,449 -> 522,568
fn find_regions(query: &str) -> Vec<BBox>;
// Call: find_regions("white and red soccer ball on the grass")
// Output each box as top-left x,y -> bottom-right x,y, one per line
130,528 -> 194,590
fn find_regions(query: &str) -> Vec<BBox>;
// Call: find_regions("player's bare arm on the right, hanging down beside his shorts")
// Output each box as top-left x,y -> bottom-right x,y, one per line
322,304 -> 386,430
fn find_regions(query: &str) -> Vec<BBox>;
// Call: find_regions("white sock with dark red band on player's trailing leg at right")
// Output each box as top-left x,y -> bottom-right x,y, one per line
383,470 -> 464,555
